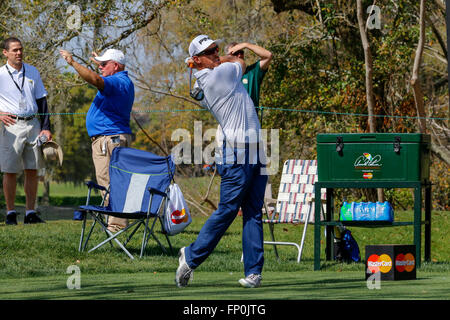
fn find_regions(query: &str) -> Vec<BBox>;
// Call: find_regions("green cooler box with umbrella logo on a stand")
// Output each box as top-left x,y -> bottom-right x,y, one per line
317,133 -> 431,182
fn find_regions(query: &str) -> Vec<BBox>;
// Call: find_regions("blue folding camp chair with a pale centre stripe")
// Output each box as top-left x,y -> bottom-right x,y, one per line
78,147 -> 175,259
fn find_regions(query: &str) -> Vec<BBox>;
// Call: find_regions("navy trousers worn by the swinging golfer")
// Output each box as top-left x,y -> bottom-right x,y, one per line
185,157 -> 268,276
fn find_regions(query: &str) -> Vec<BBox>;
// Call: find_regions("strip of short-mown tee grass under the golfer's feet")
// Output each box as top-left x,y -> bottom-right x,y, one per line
0,271 -> 450,300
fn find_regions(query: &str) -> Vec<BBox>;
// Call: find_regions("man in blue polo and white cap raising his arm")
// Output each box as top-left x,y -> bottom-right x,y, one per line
60,49 -> 134,232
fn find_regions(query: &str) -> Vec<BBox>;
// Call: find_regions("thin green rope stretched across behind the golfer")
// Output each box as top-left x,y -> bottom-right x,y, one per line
6,106 -> 450,121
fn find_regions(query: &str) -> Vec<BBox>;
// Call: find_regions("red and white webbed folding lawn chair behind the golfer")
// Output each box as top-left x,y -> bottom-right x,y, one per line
263,160 -> 326,262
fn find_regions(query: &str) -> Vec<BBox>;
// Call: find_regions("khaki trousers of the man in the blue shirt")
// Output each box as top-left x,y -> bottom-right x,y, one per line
92,134 -> 131,227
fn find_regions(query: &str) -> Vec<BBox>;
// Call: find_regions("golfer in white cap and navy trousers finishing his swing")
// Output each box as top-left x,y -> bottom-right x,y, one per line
175,35 -> 267,288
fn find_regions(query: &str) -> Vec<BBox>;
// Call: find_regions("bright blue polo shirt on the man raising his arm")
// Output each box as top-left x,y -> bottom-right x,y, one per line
86,71 -> 134,137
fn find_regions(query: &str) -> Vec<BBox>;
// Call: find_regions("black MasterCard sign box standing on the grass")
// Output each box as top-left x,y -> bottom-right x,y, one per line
366,245 -> 416,280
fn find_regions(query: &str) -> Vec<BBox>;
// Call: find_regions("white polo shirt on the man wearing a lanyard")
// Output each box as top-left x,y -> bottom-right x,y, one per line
0,63 -> 47,116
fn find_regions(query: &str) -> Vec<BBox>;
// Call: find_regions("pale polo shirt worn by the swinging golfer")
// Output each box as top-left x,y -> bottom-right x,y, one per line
194,62 -> 261,144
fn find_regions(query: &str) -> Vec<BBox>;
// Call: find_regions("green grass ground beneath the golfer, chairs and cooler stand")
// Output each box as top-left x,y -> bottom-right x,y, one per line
0,208 -> 450,300
